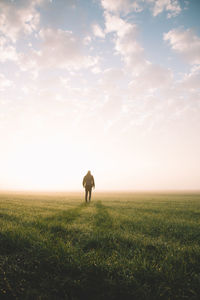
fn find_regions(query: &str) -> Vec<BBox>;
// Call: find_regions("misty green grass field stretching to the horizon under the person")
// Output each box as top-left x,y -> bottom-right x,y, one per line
0,193 -> 200,300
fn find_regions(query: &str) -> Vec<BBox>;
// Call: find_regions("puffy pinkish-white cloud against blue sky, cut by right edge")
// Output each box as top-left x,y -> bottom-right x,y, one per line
164,29 -> 200,64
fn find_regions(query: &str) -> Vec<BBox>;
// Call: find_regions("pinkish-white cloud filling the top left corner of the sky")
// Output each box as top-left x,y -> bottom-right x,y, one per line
0,0 -> 42,42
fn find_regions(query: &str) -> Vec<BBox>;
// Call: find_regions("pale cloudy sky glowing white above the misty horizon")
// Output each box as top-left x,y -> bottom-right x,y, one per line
0,0 -> 200,190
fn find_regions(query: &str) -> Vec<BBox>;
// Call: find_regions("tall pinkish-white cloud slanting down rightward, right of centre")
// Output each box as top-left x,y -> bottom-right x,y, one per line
105,12 -> 173,99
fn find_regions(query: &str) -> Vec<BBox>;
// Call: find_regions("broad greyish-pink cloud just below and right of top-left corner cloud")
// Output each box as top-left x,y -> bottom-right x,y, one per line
20,28 -> 98,70
